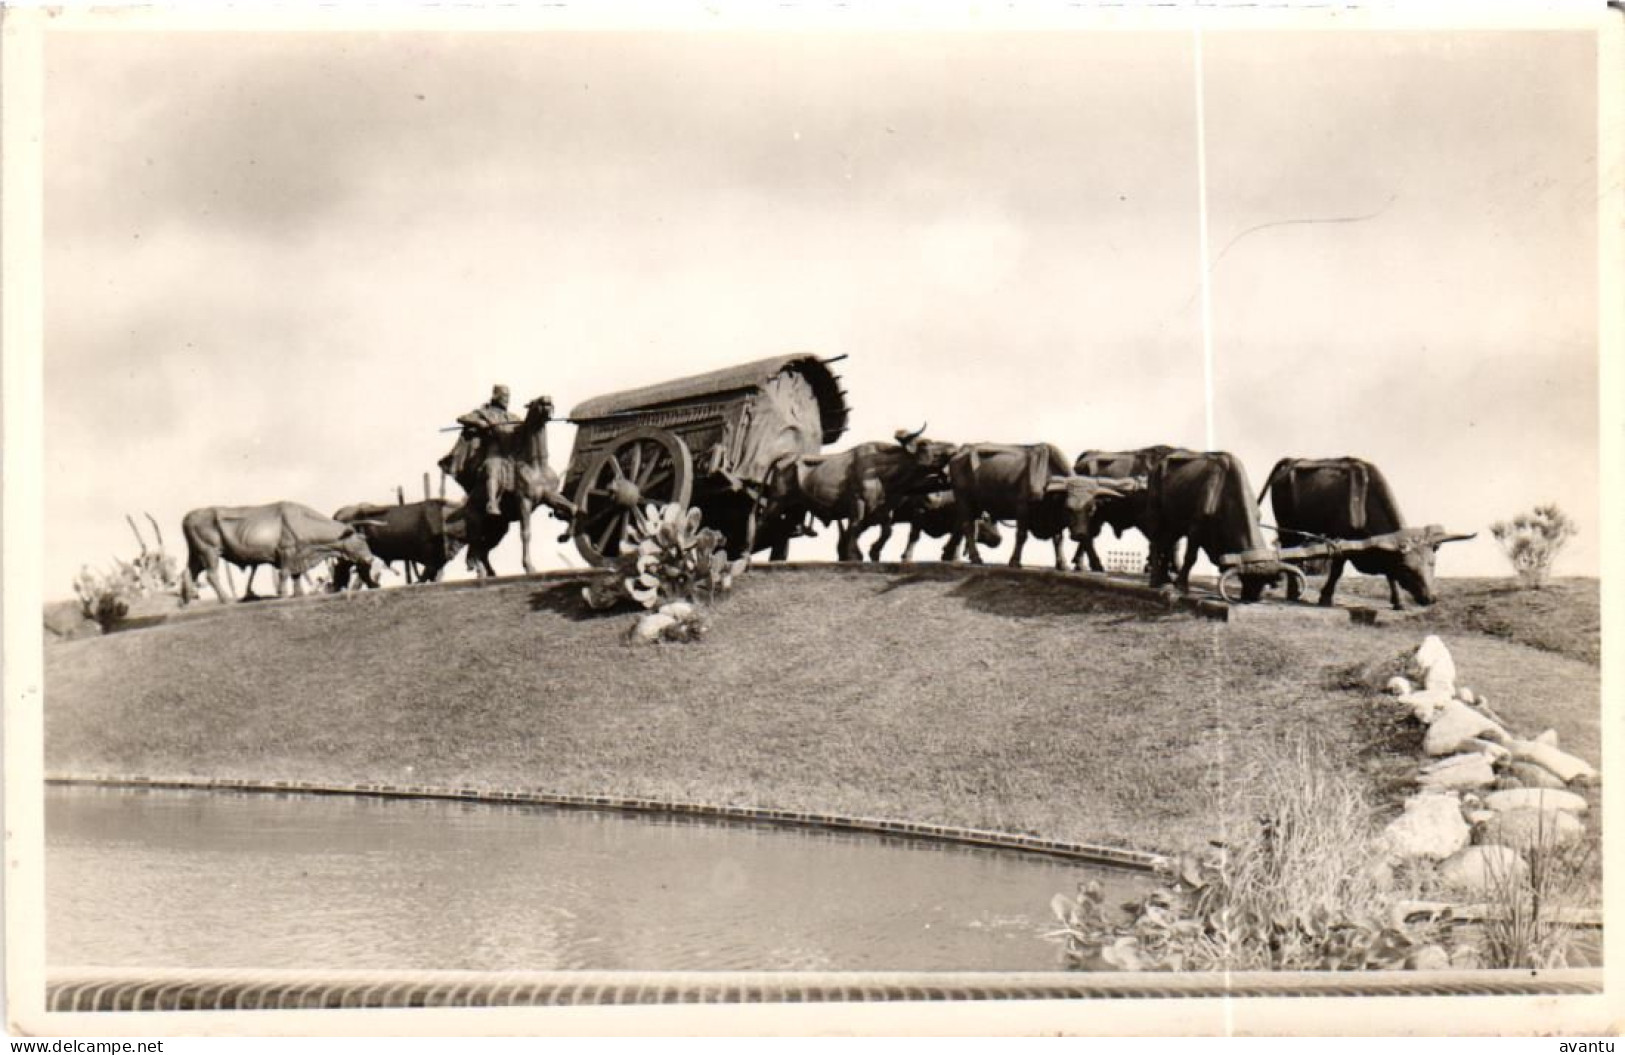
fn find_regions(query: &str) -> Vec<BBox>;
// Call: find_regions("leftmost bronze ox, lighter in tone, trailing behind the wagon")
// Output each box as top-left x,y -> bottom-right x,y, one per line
180,502 -> 377,605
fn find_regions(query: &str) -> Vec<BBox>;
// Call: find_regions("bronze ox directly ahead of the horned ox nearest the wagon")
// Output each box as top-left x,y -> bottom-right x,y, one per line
947,444 -> 1138,571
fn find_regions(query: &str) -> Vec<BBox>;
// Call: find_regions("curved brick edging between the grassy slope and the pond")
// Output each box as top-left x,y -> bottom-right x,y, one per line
46,774 -> 1170,873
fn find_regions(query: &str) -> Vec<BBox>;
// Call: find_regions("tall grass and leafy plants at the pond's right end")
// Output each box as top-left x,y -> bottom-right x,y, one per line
1051,746 -> 1443,970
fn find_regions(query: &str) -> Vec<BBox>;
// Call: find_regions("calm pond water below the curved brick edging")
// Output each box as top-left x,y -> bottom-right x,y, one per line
46,787 -> 1146,970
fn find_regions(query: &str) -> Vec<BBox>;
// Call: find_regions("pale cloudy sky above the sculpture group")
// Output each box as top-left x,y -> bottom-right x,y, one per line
31,31 -> 1601,598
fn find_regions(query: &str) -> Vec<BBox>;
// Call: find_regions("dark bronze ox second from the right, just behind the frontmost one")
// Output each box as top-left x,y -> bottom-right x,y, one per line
1146,450 -> 1303,601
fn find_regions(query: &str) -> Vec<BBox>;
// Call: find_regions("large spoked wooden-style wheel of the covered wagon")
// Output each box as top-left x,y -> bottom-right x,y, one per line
574,426 -> 694,566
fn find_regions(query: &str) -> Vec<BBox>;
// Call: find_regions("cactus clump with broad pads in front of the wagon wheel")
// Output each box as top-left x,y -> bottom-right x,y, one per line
582,504 -> 746,608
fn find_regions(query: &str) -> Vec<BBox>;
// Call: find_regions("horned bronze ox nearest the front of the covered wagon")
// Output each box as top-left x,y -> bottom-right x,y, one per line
764,426 -> 959,561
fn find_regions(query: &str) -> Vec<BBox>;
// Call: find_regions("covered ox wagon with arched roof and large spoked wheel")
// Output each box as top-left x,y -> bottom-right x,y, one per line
564,354 -> 848,564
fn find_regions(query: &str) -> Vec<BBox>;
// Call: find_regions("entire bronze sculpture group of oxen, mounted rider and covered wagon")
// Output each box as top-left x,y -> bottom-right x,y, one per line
182,354 -> 1471,608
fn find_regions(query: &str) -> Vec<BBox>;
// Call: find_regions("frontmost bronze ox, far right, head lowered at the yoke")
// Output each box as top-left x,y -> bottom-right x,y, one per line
1258,458 -> 1472,610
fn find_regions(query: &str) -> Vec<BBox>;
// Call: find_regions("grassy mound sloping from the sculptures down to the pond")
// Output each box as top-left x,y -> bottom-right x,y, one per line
46,567 -> 1599,849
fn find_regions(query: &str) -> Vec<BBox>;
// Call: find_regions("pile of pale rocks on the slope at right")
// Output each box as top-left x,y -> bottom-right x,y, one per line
1383,636 -> 1599,896
